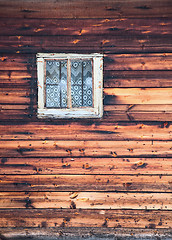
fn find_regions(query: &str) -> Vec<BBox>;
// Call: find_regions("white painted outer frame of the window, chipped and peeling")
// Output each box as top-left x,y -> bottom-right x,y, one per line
37,53 -> 103,118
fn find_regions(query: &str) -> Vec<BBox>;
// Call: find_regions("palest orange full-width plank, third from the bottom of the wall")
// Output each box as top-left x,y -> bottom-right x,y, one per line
0,191 -> 172,210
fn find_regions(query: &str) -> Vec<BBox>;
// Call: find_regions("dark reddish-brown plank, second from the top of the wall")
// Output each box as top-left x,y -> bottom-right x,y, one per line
0,17 -> 172,37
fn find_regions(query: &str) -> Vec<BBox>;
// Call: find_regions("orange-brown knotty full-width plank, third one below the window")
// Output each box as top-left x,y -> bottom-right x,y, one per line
0,156 -> 172,175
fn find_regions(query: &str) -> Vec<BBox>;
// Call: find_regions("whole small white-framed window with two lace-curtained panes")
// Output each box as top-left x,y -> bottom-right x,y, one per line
37,53 -> 103,118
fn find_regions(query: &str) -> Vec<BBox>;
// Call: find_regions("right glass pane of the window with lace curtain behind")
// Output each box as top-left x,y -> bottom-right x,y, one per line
71,60 -> 93,108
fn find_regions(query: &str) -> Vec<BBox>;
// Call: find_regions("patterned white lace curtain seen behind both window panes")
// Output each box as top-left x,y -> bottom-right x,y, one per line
46,60 -> 93,108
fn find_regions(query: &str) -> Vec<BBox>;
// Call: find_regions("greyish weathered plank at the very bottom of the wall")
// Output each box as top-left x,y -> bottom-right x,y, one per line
0,228 -> 171,240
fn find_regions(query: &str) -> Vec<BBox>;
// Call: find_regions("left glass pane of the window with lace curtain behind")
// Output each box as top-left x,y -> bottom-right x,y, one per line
46,60 -> 67,108
